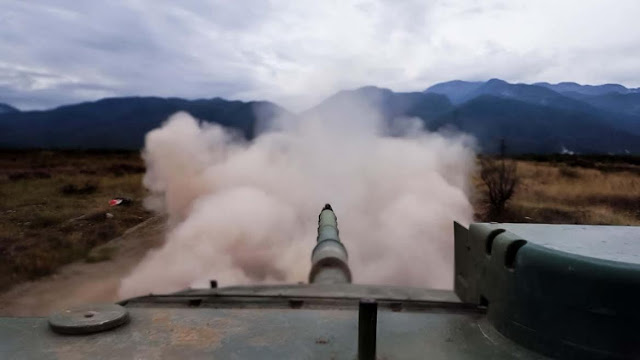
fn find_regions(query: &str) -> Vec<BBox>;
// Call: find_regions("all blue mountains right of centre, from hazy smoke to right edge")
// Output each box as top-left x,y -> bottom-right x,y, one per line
330,83 -> 640,154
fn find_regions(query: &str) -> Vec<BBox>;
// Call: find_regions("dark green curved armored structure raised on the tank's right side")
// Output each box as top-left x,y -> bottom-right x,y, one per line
455,223 -> 640,359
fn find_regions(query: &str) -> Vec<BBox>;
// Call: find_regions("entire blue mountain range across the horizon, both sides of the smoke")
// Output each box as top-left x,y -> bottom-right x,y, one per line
0,79 -> 640,154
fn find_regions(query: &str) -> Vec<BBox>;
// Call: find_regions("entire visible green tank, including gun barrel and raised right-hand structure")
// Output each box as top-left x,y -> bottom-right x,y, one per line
0,204 -> 640,360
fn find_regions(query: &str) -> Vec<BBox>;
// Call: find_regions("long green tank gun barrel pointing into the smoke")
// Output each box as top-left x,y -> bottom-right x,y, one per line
309,204 -> 351,284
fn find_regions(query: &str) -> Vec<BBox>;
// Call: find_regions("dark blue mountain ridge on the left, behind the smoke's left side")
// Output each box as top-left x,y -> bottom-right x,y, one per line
0,97 -> 287,149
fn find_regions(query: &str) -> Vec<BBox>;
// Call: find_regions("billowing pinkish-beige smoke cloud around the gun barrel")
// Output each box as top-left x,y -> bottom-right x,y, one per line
120,97 -> 474,297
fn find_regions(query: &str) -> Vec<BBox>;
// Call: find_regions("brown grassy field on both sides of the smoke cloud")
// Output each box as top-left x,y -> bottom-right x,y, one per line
0,151 -> 640,291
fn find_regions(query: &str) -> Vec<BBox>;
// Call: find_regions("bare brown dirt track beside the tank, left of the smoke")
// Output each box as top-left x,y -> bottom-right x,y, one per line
0,217 -> 165,316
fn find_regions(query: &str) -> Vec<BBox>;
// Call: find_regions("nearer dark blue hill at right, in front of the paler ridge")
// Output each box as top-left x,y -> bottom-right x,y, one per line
429,95 -> 640,154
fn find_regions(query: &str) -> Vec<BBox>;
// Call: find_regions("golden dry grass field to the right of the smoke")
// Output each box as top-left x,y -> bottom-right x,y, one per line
476,160 -> 640,225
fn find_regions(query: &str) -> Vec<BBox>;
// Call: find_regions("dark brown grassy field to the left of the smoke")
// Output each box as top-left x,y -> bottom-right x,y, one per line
0,151 -> 151,290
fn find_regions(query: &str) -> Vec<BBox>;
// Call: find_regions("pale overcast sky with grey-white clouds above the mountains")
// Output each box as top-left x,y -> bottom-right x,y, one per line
0,0 -> 640,110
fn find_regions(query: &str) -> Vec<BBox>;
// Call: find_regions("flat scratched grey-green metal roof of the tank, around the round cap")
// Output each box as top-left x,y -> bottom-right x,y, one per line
0,307 -> 544,360
